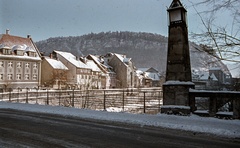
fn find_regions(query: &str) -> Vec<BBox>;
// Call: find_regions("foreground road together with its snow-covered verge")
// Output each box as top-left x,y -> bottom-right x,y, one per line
0,102 -> 240,147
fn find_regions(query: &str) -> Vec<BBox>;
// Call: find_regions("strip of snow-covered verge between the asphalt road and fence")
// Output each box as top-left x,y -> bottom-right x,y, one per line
0,102 -> 240,138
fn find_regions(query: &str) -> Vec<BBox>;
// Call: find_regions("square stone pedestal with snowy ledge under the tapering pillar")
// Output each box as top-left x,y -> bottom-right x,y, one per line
161,81 -> 195,113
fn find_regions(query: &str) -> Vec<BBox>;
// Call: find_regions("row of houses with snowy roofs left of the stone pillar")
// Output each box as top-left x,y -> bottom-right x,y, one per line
0,30 -> 161,91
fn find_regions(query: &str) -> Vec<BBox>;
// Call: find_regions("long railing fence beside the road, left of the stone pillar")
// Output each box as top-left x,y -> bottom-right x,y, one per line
0,88 -> 162,114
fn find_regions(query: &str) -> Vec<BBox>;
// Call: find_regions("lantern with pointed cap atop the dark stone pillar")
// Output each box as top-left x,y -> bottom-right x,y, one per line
167,0 -> 187,25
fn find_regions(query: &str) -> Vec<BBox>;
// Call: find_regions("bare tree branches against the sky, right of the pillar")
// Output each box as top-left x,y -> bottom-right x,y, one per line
189,0 -> 240,63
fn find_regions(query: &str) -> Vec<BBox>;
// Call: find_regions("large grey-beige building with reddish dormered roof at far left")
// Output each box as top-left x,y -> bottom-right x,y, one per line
0,30 -> 41,91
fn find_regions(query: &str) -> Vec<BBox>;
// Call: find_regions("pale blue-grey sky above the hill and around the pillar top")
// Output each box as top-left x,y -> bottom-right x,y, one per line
0,0 -> 212,41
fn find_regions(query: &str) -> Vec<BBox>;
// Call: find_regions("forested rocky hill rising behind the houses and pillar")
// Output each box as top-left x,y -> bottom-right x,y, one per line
36,32 -> 228,72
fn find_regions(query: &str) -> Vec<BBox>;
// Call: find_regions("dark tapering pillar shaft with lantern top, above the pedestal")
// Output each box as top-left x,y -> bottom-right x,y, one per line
166,0 -> 192,81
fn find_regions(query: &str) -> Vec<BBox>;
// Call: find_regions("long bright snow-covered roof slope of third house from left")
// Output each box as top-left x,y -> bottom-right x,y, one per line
54,50 -> 91,69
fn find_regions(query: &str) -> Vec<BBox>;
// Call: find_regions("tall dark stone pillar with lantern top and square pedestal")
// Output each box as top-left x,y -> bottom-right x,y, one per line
163,0 -> 194,112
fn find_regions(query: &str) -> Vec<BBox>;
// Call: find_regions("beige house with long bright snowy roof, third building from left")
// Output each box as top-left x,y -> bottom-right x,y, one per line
52,51 -> 101,90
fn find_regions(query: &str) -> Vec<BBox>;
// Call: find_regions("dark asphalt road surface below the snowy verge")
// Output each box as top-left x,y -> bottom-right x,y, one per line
0,109 -> 240,148
